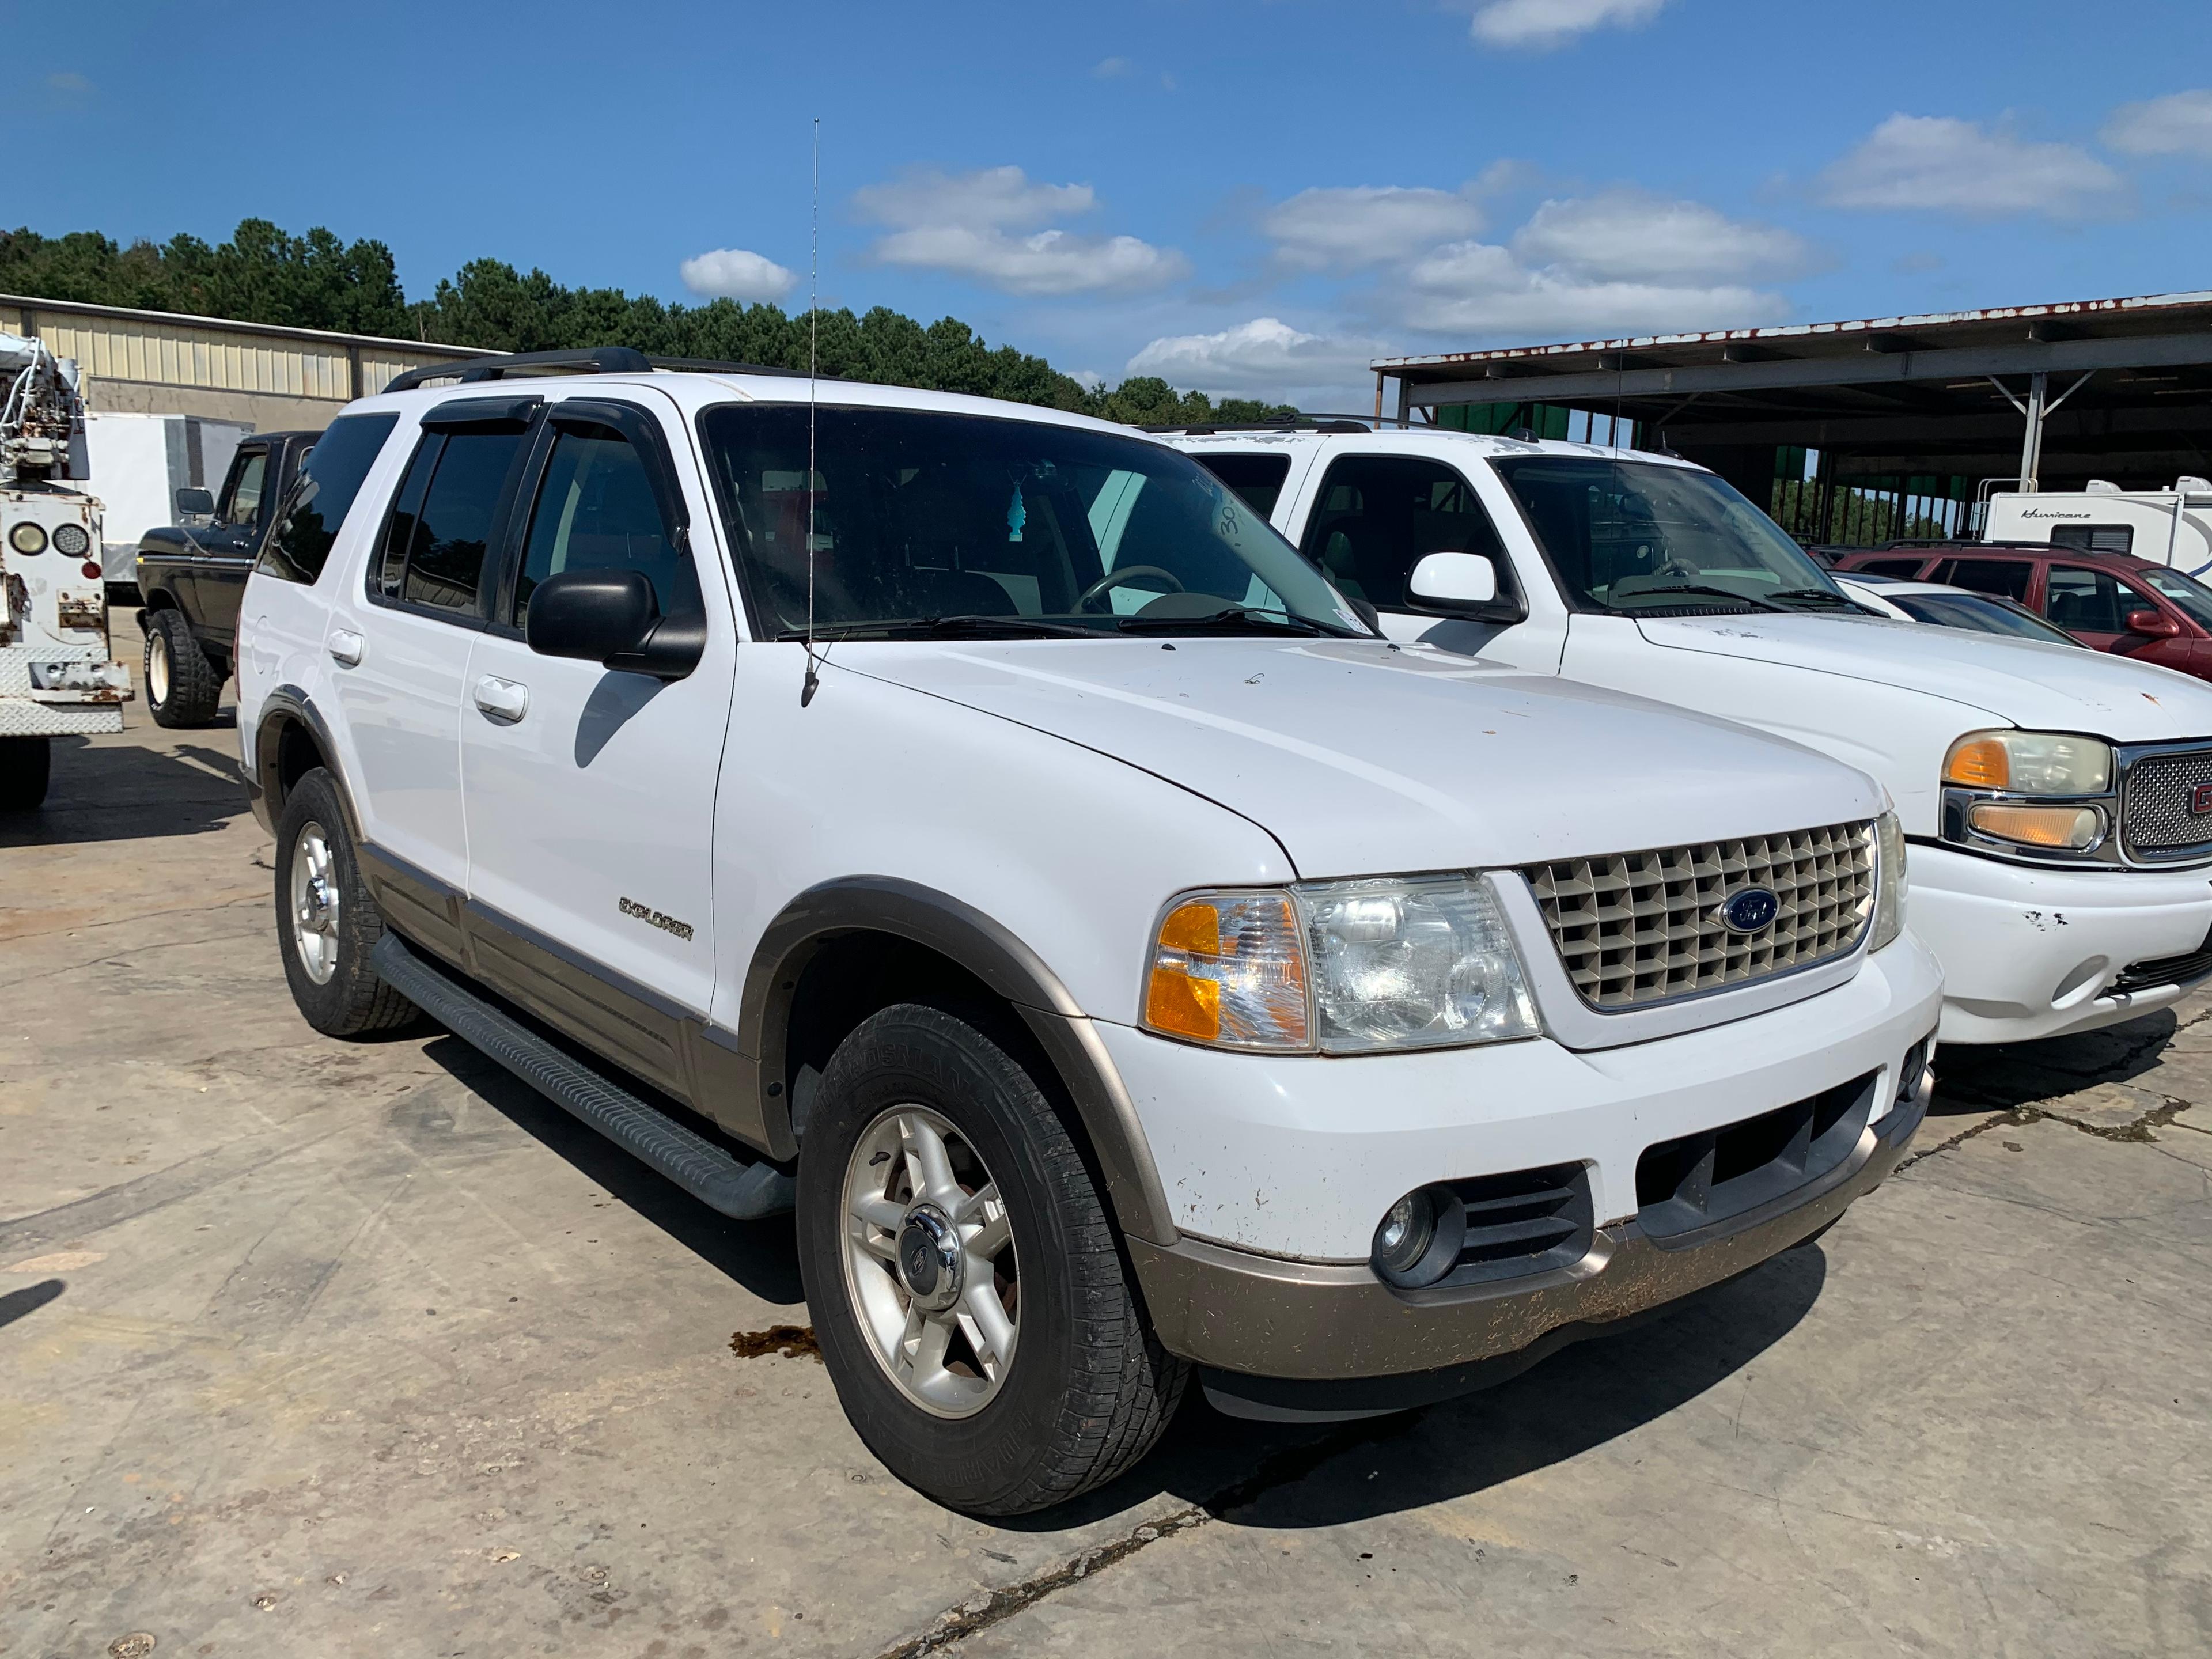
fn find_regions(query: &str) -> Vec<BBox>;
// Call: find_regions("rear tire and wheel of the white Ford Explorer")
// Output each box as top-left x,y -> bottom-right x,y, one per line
276,767 -> 422,1037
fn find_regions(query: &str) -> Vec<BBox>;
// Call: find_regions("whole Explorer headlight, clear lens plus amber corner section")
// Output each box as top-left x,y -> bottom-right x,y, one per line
1143,876 -> 1541,1055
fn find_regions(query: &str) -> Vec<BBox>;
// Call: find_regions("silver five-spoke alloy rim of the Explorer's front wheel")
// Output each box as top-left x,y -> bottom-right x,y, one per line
845,1106 -> 1022,1418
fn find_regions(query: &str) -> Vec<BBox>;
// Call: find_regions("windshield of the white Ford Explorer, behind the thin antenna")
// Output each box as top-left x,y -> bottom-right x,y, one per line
699,405 -> 1369,637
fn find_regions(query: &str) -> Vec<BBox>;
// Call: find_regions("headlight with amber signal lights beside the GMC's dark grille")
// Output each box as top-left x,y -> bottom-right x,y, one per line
1942,732 -> 2115,856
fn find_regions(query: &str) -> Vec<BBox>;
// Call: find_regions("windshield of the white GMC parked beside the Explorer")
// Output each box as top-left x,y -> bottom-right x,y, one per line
1491,456 -> 1851,613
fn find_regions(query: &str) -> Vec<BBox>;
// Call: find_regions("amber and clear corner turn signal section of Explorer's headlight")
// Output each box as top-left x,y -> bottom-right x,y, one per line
1143,892 -> 1312,1048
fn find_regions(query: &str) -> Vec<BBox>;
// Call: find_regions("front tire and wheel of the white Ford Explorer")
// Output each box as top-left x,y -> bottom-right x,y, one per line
798,1004 -> 1190,1515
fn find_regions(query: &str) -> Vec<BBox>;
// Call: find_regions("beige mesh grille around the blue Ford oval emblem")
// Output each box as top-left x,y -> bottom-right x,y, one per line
1522,821 -> 1873,1011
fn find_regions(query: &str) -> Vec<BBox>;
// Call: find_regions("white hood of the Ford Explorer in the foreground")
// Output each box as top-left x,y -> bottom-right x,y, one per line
836,639 -> 1880,878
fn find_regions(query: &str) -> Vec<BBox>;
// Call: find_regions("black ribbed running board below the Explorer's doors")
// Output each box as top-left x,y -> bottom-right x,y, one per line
369,931 -> 794,1221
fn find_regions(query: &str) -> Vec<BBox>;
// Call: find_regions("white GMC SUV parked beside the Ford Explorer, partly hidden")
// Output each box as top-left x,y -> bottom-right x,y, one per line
1177,435 -> 2212,1044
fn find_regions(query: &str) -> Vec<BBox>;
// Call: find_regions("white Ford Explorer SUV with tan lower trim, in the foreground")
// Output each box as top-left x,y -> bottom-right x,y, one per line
239,352 -> 1940,1513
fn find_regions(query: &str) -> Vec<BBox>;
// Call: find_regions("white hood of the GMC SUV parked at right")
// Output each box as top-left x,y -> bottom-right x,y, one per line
1635,613 -> 2212,743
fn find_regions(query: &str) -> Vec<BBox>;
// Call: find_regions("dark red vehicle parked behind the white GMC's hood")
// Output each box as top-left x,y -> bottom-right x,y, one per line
1836,542 -> 2212,679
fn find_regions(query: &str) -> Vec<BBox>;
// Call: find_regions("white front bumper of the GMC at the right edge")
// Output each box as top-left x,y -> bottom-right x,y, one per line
1907,843 -> 2212,1042
